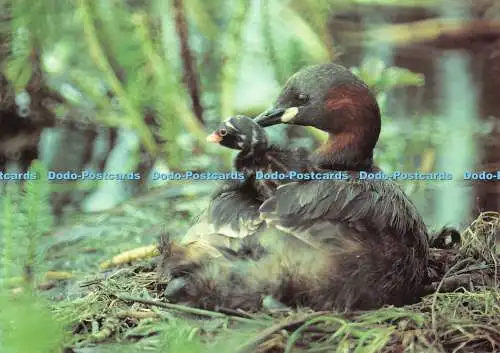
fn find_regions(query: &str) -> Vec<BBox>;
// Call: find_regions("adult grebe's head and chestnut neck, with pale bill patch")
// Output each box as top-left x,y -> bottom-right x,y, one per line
255,63 -> 381,169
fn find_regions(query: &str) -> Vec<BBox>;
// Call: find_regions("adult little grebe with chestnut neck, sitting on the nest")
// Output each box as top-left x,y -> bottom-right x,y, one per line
159,64 -> 429,310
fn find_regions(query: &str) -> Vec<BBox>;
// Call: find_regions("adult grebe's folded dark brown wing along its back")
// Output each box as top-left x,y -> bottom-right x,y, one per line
259,180 -> 427,248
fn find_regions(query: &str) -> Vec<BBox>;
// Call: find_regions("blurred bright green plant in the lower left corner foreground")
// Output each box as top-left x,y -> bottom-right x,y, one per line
0,162 -> 64,353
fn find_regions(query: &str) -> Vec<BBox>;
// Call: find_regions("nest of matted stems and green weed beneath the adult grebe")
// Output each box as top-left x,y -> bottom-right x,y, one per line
56,212 -> 500,353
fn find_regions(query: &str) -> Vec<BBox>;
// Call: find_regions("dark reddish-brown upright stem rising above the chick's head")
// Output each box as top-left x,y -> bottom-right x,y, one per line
172,0 -> 203,124
